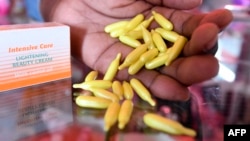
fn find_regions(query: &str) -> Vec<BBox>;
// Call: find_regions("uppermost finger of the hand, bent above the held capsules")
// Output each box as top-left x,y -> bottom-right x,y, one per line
153,7 -> 233,37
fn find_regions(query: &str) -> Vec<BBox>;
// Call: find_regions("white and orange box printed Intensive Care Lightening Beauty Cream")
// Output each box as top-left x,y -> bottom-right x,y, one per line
0,22 -> 71,91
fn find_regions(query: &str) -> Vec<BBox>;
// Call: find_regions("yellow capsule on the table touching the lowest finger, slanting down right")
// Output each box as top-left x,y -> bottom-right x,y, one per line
130,78 -> 156,106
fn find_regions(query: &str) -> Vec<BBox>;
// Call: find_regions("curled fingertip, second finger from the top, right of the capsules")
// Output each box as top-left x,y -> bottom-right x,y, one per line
183,23 -> 219,56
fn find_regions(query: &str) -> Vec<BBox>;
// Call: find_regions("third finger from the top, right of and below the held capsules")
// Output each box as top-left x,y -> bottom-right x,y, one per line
160,55 -> 219,86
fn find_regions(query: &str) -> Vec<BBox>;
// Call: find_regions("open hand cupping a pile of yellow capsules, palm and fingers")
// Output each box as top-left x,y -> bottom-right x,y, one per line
41,0 -> 232,101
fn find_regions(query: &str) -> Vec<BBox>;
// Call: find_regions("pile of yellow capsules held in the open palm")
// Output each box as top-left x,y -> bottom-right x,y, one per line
104,11 -> 187,75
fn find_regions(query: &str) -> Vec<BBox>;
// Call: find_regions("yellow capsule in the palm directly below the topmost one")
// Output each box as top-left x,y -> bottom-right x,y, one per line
155,28 -> 180,43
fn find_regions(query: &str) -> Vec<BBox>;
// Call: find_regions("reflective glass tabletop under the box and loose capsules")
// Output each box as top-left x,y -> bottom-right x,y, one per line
0,78 -> 207,141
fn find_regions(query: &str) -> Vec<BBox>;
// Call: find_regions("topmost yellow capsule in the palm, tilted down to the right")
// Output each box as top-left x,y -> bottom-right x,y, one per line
152,11 -> 174,30
